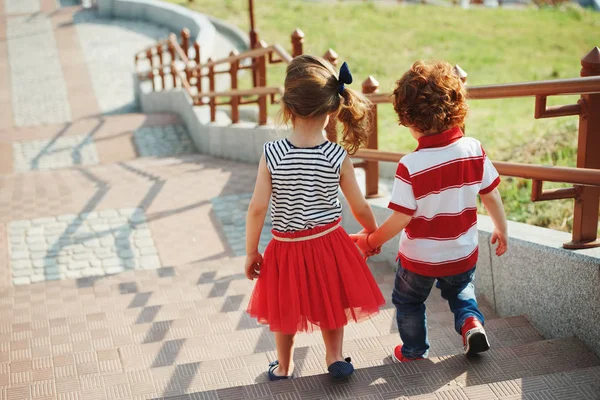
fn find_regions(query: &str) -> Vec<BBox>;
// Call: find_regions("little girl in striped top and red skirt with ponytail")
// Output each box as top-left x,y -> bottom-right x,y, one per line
245,55 -> 385,380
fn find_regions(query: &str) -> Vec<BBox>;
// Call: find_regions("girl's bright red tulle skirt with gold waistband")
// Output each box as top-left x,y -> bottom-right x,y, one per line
247,220 -> 385,334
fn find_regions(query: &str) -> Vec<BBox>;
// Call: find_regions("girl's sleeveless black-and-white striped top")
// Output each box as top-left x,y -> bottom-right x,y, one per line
264,139 -> 346,232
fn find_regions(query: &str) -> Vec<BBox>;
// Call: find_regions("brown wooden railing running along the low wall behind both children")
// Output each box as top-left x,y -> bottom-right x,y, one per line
135,29 -> 600,249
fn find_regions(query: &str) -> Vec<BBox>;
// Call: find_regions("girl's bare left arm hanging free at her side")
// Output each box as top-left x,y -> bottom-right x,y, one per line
245,155 -> 271,280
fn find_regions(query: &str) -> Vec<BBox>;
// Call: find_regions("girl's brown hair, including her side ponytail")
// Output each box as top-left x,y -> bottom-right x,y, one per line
281,55 -> 371,154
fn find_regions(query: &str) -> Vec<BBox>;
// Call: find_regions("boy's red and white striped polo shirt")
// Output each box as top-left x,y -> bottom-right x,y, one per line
388,128 -> 500,277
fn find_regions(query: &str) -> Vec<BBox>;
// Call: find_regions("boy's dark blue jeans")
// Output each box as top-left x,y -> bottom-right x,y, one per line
392,264 -> 484,358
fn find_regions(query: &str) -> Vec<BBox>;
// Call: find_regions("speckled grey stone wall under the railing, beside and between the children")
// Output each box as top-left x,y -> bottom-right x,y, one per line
343,197 -> 600,355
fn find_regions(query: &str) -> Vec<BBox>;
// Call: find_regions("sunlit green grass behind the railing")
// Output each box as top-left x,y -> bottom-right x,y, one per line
168,0 -> 600,230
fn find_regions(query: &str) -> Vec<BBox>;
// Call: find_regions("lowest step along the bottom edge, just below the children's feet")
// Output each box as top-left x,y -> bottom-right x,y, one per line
168,361 -> 600,400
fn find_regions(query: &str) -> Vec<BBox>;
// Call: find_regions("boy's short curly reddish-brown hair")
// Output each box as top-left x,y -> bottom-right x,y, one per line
394,61 -> 468,135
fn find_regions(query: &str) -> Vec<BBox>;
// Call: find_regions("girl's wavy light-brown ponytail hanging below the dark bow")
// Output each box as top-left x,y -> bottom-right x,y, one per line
337,87 -> 372,154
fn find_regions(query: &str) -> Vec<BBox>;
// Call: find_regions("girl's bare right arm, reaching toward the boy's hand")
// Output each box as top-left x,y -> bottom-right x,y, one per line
340,157 -> 377,232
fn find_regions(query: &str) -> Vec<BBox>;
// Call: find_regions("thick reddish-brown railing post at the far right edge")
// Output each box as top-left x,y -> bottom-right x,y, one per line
564,47 -> 600,249
